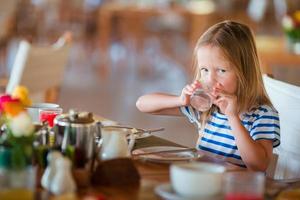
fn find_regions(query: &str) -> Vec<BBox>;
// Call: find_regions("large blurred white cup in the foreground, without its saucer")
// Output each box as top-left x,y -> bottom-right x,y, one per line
170,162 -> 225,199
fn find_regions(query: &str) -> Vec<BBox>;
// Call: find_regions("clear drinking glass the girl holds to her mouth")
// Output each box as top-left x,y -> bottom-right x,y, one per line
190,88 -> 212,112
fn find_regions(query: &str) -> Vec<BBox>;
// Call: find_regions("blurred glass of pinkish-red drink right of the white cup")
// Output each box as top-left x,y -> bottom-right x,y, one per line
223,171 -> 265,200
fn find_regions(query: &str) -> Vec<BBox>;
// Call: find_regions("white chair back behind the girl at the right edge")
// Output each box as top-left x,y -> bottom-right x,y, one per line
263,75 -> 300,179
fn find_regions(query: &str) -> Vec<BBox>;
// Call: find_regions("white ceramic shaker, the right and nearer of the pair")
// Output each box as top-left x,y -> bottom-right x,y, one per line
50,157 -> 76,195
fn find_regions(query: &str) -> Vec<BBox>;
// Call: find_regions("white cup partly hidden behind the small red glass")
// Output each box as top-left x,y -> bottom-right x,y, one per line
26,103 -> 59,124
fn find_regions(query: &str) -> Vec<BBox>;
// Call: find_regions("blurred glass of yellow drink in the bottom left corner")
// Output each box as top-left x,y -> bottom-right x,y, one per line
0,167 -> 36,200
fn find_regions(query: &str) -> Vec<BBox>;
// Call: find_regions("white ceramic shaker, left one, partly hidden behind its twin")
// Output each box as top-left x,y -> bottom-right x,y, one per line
41,151 -> 62,190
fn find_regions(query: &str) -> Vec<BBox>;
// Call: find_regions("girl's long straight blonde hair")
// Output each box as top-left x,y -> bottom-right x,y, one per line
194,21 -> 272,122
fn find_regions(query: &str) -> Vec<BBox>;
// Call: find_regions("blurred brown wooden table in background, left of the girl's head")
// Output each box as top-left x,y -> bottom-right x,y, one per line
98,3 -> 219,49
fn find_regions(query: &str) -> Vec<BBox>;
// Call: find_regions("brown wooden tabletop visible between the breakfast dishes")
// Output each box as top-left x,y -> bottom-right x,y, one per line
37,136 -> 300,200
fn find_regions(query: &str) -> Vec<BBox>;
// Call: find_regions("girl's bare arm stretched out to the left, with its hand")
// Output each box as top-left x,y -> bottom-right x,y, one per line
136,81 -> 201,115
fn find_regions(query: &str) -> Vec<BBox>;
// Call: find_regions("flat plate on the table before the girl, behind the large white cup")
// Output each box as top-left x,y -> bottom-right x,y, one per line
132,146 -> 201,163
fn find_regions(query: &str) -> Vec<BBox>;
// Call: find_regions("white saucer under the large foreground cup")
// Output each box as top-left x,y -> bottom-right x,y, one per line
154,183 -> 223,200
